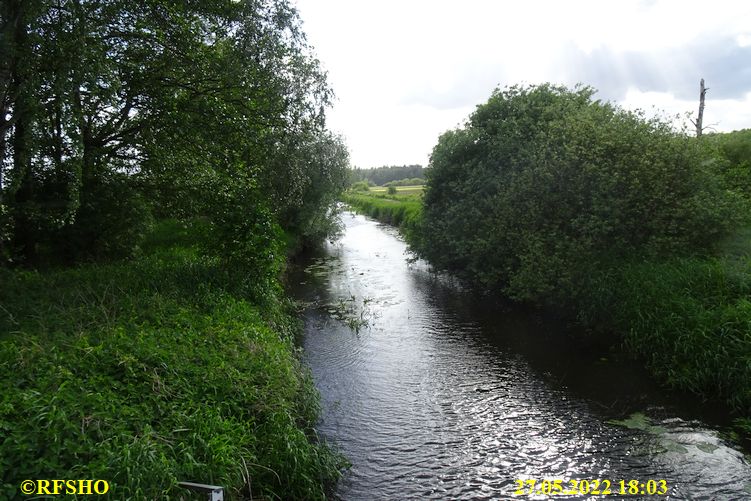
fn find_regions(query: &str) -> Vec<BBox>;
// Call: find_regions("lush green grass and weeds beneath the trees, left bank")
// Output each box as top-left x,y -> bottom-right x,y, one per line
0,222 -> 342,499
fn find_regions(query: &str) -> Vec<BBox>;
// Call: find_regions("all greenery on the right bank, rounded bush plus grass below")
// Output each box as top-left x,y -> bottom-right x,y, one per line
418,85 -> 751,428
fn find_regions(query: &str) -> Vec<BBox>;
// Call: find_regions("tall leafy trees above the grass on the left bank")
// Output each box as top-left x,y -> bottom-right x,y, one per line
0,0 -> 347,265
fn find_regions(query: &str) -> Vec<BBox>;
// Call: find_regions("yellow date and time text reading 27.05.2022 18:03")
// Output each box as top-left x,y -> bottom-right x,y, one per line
514,478 -> 670,496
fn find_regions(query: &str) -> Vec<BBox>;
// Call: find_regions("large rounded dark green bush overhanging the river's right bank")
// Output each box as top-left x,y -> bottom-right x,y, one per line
420,85 -> 742,304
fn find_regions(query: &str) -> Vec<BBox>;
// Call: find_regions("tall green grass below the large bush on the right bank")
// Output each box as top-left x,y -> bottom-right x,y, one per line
584,226 -> 751,419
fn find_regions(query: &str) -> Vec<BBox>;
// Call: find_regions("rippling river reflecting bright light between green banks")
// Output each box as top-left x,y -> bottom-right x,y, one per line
292,213 -> 751,500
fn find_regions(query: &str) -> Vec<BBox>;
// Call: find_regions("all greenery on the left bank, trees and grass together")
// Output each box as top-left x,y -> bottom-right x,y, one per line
0,0 -> 348,499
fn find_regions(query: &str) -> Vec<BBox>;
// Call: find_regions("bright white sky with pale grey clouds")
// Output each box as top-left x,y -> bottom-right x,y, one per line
293,0 -> 751,168
